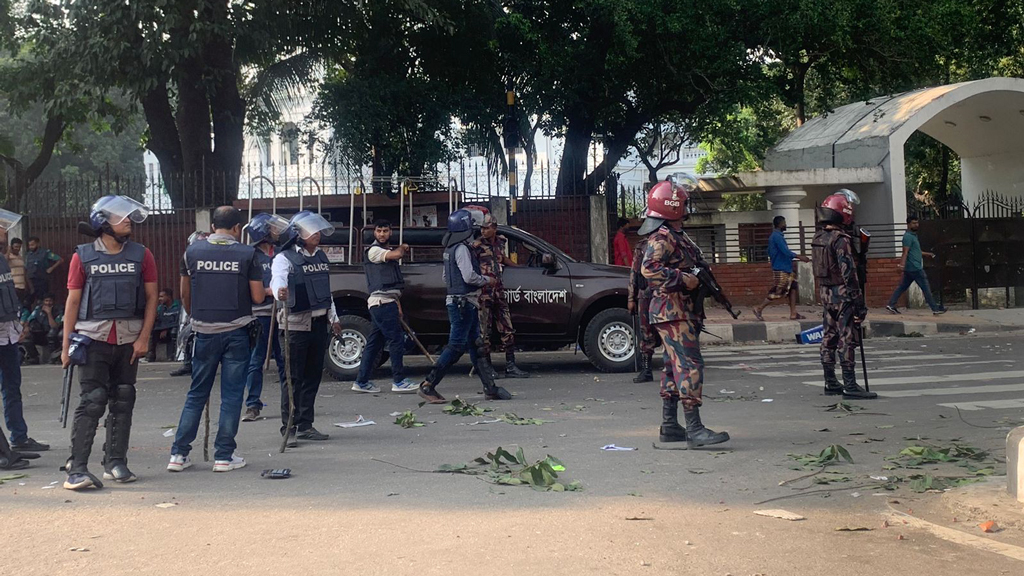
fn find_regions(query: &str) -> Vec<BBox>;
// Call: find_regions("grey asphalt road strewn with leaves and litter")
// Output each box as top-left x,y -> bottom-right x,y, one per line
0,335 -> 1024,574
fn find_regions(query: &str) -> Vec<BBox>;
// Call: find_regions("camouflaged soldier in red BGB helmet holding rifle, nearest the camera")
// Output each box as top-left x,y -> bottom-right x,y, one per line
640,177 -> 729,448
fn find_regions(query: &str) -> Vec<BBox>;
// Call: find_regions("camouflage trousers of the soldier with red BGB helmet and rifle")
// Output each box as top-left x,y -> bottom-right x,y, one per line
654,320 -> 703,408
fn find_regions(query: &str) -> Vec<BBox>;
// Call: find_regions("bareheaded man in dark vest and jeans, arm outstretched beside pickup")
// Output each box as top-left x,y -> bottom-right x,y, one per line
352,218 -> 417,394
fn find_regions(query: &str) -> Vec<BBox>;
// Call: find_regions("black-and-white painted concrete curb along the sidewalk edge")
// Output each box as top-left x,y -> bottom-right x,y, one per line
703,320 -> 1024,345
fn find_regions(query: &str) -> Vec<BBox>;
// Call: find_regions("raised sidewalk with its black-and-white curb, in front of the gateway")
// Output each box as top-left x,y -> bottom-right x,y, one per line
703,305 -> 1024,345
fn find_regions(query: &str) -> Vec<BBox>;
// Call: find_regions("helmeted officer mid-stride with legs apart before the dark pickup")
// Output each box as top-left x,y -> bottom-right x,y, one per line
419,210 -> 512,404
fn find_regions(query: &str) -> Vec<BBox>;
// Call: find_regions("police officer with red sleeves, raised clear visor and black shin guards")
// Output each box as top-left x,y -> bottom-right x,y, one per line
60,196 -> 157,490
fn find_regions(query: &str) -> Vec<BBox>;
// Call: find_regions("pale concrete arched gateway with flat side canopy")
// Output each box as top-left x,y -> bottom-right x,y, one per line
701,78 -> 1024,249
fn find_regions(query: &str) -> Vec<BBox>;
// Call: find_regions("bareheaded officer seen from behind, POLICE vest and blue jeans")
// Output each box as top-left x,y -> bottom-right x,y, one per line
167,206 -> 266,472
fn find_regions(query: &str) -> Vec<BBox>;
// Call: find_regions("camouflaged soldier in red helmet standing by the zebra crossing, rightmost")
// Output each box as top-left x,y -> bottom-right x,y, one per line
811,190 -> 878,400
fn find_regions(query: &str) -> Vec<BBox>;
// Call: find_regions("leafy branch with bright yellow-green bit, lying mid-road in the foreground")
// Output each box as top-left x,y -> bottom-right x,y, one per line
436,446 -> 583,492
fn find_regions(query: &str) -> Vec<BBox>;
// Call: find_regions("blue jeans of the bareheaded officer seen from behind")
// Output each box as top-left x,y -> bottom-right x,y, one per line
171,328 -> 251,460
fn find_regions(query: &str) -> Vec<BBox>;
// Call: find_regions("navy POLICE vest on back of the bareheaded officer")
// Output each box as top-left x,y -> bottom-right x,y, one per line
185,240 -> 254,322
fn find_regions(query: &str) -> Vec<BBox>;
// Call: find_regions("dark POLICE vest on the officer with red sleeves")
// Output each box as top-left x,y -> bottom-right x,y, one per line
76,241 -> 145,320
